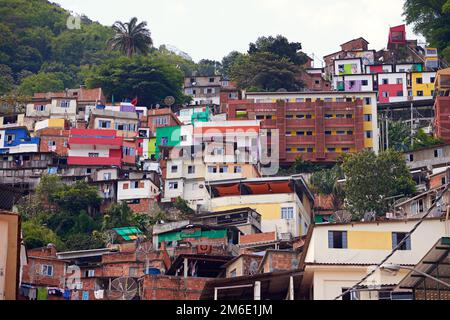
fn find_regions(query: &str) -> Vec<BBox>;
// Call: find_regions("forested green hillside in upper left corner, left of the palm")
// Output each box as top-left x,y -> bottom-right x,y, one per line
0,0 -> 114,94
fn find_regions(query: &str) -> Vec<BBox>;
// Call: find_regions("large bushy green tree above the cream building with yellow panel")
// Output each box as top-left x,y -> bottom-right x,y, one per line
342,150 -> 415,218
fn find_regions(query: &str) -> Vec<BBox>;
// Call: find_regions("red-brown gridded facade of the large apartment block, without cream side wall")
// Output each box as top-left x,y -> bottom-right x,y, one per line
228,99 -> 365,164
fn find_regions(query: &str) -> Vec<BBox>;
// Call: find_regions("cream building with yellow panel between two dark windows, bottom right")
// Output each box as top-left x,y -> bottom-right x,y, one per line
301,218 -> 450,300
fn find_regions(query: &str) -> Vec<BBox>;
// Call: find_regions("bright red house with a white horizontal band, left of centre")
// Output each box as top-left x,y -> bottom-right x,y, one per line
67,129 -> 123,167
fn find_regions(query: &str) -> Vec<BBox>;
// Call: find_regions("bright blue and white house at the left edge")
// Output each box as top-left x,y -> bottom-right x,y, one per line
0,127 -> 39,154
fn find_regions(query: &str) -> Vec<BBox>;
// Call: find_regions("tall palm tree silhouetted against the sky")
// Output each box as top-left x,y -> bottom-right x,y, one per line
108,17 -> 153,58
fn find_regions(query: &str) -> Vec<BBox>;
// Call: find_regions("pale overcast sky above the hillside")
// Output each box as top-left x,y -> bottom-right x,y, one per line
53,0 -> 417,67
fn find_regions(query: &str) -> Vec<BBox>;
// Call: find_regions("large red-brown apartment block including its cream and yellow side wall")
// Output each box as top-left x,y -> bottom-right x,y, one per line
228,92 -> 379,163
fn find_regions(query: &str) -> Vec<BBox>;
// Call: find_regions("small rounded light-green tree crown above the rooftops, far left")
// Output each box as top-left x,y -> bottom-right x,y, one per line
18,72 -> 64,96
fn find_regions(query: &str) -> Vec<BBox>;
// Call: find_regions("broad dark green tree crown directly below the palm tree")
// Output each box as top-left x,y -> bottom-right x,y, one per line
86,54 -> 188,106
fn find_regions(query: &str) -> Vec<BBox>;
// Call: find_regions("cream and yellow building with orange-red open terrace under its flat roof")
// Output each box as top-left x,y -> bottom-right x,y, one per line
206,176 -> 314,239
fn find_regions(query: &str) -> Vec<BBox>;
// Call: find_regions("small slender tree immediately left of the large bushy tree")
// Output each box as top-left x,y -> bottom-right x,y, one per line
311,165 -> 345,212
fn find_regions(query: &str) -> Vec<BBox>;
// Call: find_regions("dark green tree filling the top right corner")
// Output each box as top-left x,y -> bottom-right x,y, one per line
403,0 -> 450,63
